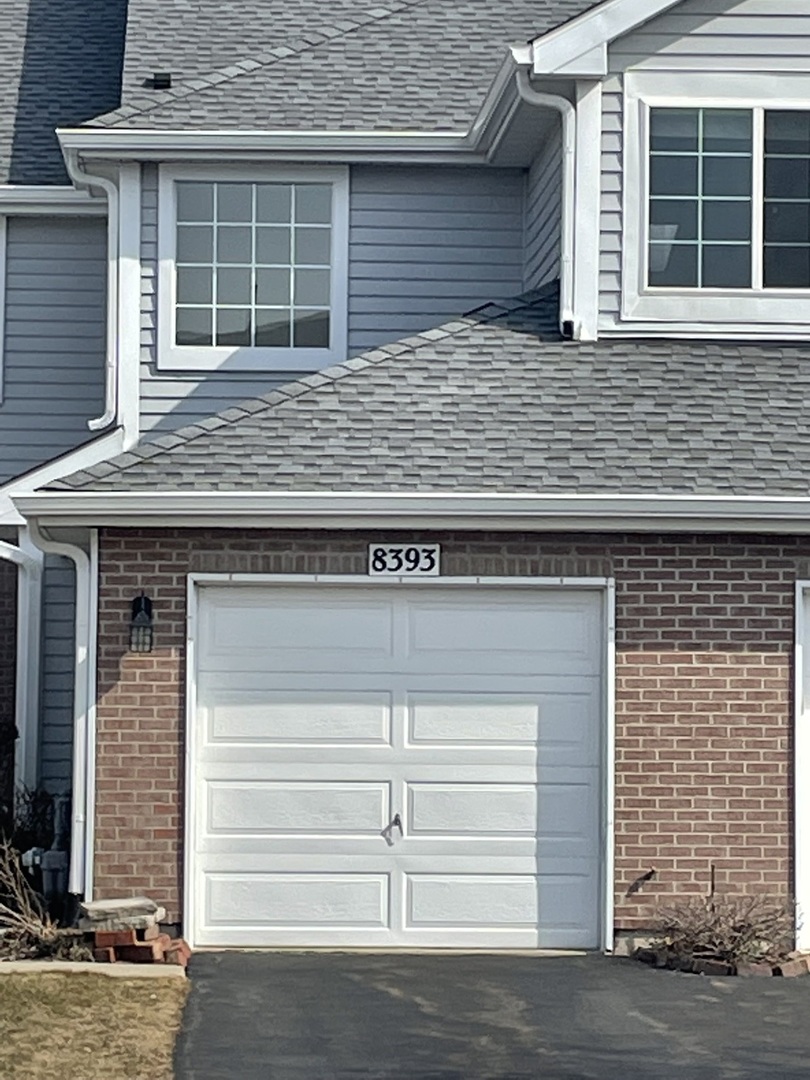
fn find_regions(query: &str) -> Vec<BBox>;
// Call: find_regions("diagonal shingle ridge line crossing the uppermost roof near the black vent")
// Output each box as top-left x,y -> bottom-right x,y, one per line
89,0 -> 438,127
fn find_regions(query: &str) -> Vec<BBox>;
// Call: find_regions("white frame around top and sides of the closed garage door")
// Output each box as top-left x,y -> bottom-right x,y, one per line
183,573 -> 616,953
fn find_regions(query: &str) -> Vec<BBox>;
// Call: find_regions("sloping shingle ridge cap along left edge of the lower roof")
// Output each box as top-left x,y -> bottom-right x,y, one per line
57,282 -> 557,489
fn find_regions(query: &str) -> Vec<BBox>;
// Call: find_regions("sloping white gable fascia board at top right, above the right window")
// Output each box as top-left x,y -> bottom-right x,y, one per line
531,0 -> 680,78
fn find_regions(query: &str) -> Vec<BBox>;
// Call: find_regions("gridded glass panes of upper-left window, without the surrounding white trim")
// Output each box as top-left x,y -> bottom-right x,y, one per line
174,180 -> 333,350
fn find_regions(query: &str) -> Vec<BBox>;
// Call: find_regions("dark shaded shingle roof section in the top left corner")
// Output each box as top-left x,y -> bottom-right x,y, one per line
0,0 -> 126,184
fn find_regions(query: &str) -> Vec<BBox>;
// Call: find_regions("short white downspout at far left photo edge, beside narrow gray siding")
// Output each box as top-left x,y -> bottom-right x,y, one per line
0,541 -> 42,787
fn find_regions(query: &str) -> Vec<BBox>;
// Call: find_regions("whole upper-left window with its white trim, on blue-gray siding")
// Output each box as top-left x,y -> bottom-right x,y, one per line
159,167 -> 348,370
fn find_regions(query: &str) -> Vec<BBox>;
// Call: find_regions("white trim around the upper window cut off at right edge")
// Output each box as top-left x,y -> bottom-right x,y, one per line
621,71 -> 810,328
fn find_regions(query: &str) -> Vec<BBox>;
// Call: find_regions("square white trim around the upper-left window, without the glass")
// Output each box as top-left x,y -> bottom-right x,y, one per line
158,164 -> 349,372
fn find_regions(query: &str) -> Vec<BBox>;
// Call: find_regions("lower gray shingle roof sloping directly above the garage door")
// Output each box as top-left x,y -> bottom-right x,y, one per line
51,291 -> 810,496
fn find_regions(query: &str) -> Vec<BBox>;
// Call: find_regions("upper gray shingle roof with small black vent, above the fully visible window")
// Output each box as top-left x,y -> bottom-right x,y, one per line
90,0 -> 594,131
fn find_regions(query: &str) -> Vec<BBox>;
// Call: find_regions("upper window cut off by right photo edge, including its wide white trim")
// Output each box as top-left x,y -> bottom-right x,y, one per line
621,71 -> 810,332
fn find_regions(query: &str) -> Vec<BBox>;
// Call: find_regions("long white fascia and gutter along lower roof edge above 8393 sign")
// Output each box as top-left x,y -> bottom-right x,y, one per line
14,490 -> 810,534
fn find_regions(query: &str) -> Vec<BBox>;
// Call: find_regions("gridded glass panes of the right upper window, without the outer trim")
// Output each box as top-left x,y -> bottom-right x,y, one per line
647,108 -> 810,291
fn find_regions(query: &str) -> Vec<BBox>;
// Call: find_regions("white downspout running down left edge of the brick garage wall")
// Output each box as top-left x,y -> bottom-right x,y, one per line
28,522 -> 95,894
